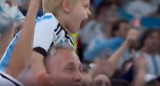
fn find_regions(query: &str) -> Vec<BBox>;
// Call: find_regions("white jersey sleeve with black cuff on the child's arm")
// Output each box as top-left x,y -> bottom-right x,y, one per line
33,18 -> 58,57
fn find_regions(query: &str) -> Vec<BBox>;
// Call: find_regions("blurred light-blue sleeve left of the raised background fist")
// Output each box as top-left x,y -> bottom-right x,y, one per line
84,38 -> 124,61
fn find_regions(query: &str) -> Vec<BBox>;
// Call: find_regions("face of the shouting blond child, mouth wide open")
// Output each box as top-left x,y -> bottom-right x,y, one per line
68,0 -> 91,33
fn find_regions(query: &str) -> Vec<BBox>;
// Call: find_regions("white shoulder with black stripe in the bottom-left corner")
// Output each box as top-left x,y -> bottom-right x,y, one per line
0,72 -> 24,86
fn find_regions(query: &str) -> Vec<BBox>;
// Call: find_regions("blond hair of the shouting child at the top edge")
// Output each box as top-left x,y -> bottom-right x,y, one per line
43,0 -> 79,15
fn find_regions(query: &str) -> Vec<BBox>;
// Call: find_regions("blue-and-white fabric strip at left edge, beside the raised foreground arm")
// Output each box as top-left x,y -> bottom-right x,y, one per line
0,32 -> 20,72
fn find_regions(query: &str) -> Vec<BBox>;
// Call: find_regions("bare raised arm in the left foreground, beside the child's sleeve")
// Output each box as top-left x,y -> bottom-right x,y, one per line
7,0 -> 41,78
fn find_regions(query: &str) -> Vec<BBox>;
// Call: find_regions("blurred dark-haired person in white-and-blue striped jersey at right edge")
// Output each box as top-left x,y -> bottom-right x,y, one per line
137,29 -> 160,77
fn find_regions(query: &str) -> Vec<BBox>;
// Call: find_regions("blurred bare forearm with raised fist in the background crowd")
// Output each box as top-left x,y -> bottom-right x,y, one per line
106,29 -> 140,77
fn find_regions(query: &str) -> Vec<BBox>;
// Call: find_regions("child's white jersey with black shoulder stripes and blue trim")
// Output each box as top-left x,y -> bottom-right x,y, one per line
33,13 -> 75,56
